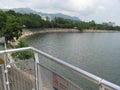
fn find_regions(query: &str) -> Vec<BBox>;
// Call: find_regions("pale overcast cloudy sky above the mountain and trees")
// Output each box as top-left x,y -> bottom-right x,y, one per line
0,0 -> 120,25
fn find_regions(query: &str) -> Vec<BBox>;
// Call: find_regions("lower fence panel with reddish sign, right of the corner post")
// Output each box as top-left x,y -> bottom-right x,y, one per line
38,64 -> 83,90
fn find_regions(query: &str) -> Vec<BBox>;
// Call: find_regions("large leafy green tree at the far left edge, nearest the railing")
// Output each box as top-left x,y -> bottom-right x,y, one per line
0,11 -> 22,43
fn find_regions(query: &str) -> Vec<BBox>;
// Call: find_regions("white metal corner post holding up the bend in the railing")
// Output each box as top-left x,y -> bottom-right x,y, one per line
34,52 -> 42,90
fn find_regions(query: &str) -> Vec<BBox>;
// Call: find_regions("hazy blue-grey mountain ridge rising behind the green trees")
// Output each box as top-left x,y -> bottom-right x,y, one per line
13,8 -> 81,21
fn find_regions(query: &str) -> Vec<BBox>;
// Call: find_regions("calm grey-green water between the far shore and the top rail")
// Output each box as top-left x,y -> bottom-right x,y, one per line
27,33 -> 120,88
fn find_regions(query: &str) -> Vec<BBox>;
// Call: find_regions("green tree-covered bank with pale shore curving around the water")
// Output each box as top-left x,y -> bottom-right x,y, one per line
0,10 -> 120,59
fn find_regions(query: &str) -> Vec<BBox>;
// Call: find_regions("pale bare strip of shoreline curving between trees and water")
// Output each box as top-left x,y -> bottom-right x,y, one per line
21,28 -> 120,38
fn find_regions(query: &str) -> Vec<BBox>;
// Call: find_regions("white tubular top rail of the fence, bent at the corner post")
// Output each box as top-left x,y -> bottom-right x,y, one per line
0,47 -> 120,90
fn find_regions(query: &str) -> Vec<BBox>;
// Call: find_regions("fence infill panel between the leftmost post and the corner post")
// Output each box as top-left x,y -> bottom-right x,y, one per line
8,60 -> 35,90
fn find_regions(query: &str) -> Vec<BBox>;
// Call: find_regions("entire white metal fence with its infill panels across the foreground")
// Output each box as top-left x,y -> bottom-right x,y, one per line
0,47 -> 120,90
